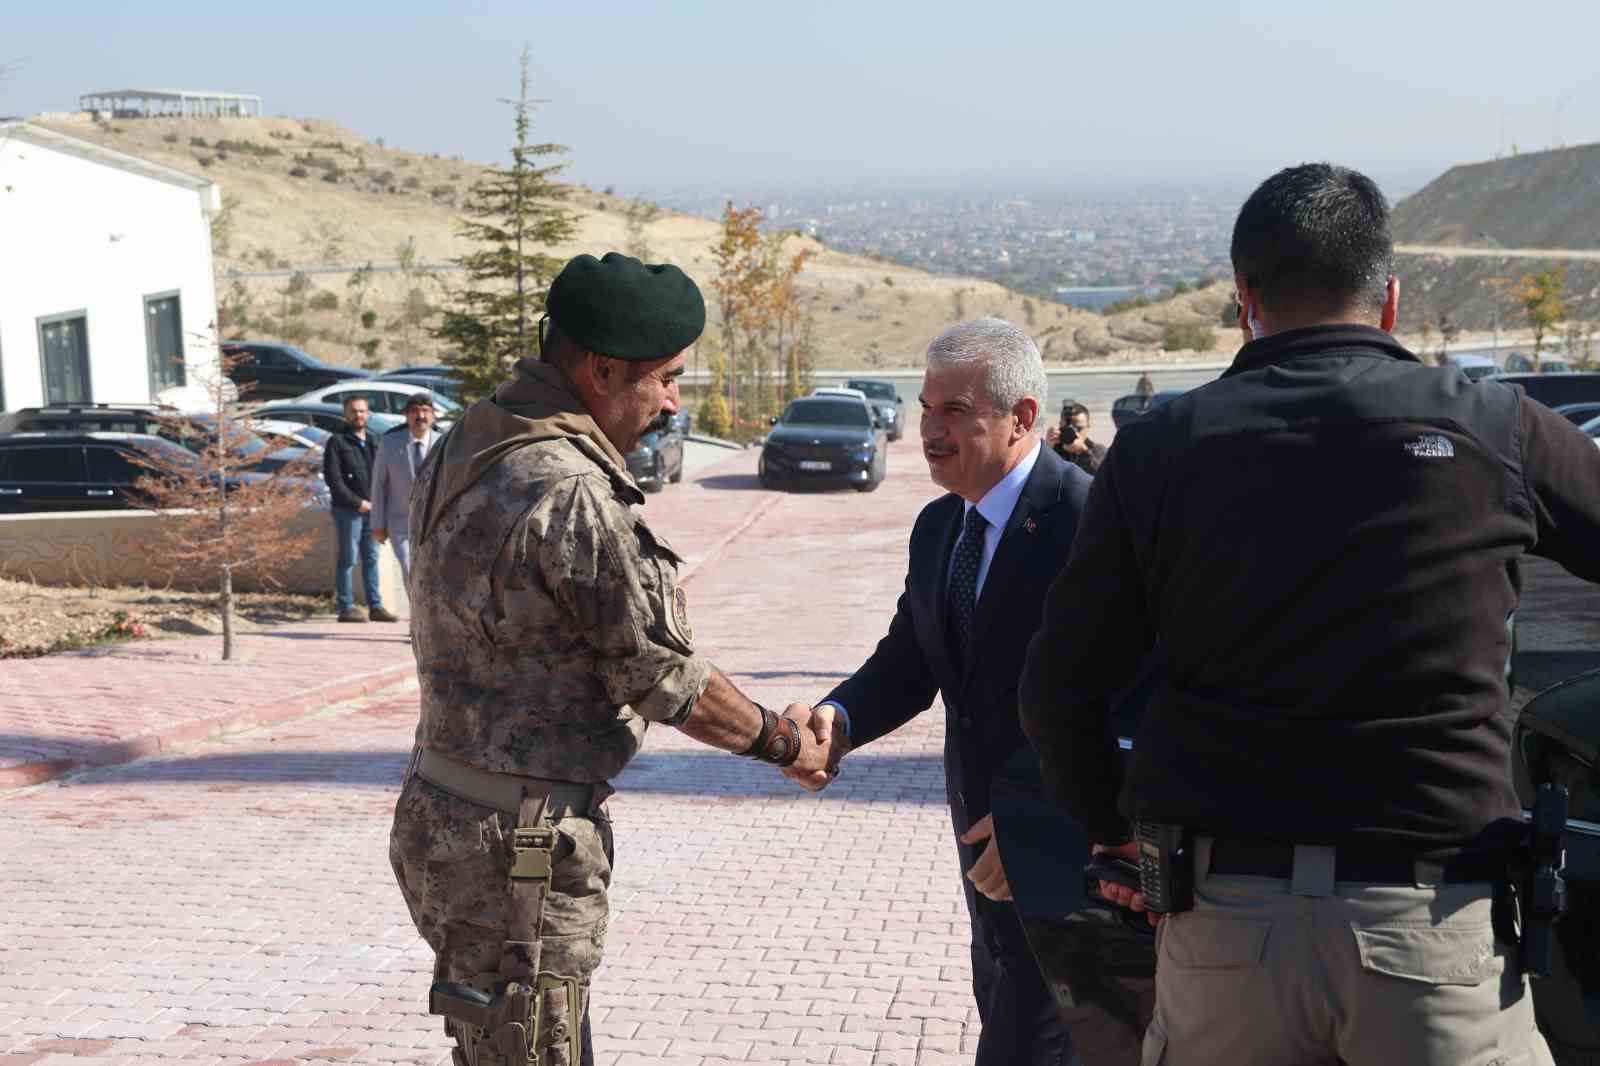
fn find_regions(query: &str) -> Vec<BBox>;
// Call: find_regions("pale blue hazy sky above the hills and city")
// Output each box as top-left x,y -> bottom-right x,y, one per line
9,0 -> 1600,192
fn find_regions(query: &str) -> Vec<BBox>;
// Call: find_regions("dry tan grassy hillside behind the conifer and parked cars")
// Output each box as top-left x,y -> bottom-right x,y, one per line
43,117 -> 1226,368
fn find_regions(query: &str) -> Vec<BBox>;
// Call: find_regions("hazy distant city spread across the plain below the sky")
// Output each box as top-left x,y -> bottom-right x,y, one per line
646,186 -> 1248,311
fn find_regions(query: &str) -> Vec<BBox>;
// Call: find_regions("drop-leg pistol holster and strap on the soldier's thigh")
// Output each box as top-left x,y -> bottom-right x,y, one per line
427,789 -> 582,1066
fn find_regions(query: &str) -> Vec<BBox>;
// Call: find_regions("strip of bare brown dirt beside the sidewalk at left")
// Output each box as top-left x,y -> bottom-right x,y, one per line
0,578 -> 333,659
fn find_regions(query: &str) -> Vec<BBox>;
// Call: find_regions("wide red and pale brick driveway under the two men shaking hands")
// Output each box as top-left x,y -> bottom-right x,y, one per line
0,428 -> 978,1066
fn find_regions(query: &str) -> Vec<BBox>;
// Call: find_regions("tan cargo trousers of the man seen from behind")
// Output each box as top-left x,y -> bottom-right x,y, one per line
1142,837 -> 1552,1066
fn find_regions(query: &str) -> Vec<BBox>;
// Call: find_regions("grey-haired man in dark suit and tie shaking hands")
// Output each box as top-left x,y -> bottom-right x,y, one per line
790,319 -> 1090,1066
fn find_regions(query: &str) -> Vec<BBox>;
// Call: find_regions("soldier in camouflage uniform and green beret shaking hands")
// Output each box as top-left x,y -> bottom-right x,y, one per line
389,253 -> 837,1066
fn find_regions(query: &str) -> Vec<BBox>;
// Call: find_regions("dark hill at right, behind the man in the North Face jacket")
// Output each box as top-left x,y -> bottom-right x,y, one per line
1394,144 -> 1600,330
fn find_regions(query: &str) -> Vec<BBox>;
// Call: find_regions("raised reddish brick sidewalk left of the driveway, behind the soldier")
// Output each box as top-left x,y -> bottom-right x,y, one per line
0,438 -> 778,791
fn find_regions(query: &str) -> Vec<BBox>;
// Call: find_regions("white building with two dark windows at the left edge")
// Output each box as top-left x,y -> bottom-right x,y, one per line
0,122 -> 221,411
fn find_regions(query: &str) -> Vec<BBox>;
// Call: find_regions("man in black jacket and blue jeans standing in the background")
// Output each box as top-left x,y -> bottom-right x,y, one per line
322,395 -> 400,623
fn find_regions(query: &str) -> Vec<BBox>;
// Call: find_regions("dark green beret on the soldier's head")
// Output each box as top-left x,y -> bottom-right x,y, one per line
544,251 -> 706,362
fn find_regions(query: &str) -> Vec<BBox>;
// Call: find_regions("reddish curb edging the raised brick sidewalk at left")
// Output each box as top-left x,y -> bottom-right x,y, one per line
0,663 -> 416,792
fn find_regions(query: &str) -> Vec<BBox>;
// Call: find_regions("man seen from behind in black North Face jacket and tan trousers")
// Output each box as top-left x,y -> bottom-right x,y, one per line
1021,165 -> 1600,1066
